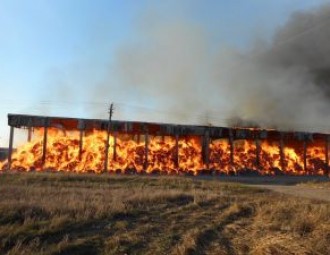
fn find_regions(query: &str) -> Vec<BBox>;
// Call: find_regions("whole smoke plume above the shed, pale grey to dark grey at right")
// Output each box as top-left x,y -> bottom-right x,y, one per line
109,5 -> 330,132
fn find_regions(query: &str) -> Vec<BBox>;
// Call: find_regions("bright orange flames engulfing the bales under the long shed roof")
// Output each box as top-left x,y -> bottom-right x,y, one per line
0,128 -> 327,175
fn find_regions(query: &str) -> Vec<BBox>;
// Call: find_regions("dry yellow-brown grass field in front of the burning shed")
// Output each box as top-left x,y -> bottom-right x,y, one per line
0,173 -> 330,254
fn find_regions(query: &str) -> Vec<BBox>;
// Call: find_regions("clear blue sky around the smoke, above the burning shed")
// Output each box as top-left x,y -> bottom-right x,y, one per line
0,0 -> 329,146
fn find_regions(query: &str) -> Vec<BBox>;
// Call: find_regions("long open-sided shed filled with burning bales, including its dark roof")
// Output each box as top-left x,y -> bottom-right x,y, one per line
0,114 -> 329,175
